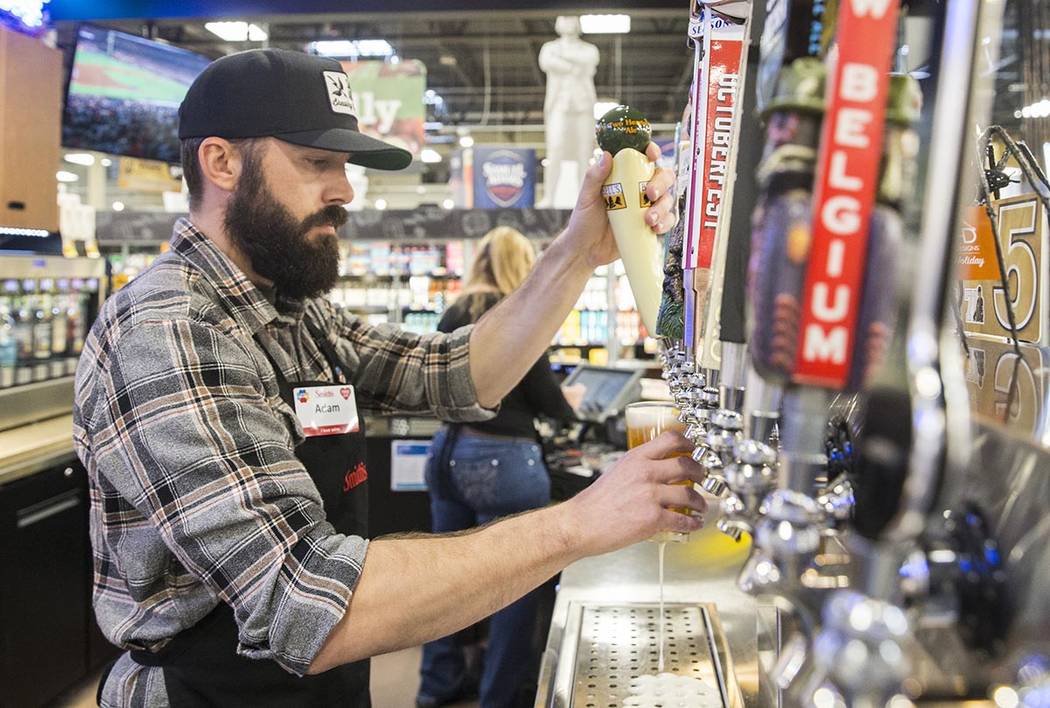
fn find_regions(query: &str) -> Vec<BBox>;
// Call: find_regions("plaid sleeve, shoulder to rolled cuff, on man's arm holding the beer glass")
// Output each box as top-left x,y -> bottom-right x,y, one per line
91,318 -> 368,674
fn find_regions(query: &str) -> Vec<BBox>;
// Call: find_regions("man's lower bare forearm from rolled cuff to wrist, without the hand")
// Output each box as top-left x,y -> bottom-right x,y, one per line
310,504 -> 582,673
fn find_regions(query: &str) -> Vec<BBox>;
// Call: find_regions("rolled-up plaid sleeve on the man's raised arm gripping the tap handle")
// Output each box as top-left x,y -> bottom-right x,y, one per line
326,306 -> 498,421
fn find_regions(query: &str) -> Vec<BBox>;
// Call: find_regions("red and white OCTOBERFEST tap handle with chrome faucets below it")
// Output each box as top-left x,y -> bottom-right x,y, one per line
672,1 -> 752,502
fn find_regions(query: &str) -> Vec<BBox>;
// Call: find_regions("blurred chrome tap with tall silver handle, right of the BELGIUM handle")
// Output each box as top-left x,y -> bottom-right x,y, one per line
784,2 -> 1012,706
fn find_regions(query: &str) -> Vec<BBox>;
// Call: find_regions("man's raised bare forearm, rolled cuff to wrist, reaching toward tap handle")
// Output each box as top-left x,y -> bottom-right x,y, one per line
470,237 -> 593,408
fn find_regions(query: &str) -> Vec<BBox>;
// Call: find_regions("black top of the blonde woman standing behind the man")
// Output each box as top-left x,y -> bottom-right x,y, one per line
438,293 -> 575,438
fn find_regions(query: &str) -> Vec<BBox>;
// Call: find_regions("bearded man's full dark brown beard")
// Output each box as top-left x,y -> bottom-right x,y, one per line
224,155 -> 347,298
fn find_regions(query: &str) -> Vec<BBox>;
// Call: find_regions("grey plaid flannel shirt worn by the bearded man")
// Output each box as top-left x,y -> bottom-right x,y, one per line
74,220 -> 491,706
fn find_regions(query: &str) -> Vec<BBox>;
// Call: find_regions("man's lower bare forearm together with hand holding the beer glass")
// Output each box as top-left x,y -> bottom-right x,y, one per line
310,432 -> 707,673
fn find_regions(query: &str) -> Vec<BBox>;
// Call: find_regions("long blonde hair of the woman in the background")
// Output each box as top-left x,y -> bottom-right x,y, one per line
461,226 -> 536,318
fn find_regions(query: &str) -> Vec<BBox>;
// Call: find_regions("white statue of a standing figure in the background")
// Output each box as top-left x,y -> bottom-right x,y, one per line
537,16 -> 599,208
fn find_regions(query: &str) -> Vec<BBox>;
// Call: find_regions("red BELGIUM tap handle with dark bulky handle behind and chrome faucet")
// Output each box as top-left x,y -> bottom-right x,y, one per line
720,3 -> 918,666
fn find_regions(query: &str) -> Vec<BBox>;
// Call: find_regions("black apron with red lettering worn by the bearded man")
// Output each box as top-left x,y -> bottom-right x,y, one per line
125,321 -> 372,708
